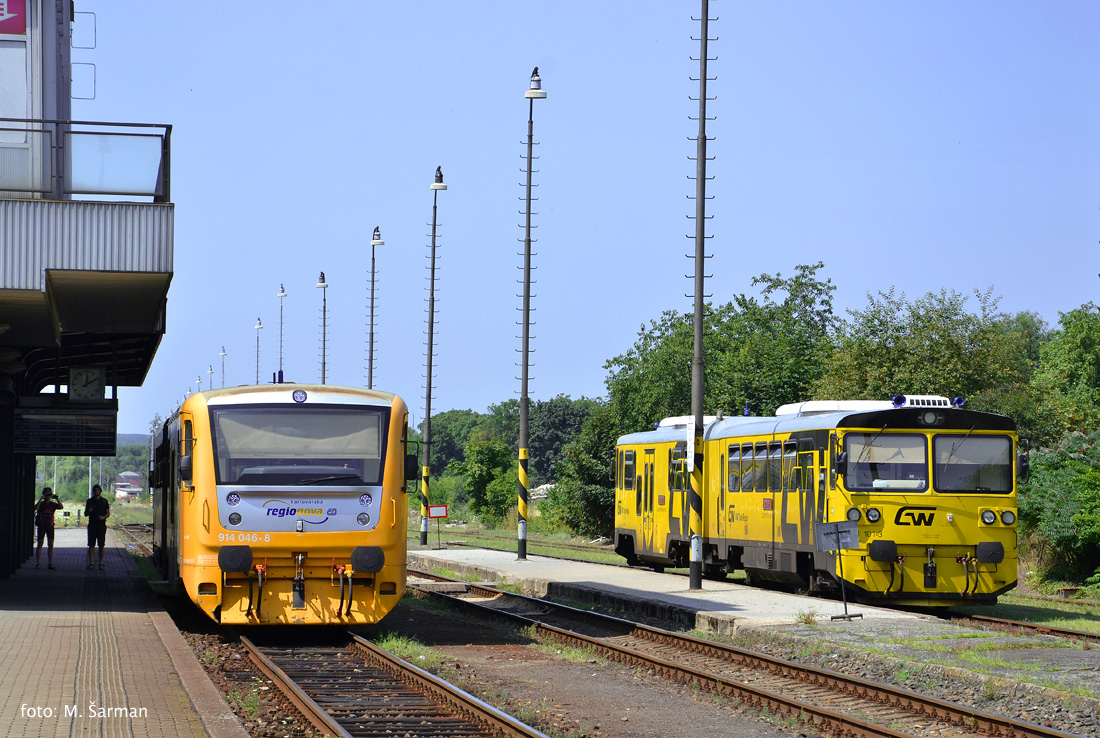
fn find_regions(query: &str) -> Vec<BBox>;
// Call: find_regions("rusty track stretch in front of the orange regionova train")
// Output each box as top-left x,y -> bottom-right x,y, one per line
241,634 -> 546,738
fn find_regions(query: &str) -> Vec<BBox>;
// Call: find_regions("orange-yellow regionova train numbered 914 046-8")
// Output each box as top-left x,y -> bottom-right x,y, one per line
153,384 -> 418,625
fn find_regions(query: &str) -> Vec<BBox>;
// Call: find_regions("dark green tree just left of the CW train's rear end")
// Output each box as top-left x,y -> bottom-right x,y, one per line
540,405 -> 618,537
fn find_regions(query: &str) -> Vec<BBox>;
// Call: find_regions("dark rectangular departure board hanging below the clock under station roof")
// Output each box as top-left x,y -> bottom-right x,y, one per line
14,408 -> 118,456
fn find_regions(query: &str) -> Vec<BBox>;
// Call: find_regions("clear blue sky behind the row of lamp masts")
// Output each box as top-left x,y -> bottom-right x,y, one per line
74,0 -> 1100,432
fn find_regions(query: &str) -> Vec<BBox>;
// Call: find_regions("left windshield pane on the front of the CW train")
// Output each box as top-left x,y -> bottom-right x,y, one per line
844,431 -> 928,492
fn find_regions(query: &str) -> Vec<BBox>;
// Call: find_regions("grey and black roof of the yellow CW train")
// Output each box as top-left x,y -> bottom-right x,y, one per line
618,400 -> 1016,445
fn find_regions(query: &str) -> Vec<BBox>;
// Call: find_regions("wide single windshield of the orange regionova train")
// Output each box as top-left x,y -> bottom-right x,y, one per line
210,405 -> 389,487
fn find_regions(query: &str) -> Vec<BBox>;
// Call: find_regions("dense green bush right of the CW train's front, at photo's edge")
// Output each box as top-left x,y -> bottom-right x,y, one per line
1016,430 -> 1100,576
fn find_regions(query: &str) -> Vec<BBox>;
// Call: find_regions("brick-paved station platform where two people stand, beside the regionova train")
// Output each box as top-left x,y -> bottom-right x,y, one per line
0,528 -> 248,738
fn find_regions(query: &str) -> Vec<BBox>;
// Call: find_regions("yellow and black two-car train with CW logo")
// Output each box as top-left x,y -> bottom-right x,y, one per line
615,395 -> 1027,606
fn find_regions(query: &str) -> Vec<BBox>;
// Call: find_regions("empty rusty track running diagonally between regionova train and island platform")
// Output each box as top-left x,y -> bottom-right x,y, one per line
409,570 -> 1073,738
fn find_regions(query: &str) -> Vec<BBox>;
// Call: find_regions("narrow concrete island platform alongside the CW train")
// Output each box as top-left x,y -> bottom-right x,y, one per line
408,548 -> 922,635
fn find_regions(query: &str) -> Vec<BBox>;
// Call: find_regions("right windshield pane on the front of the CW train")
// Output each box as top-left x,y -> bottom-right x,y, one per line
932,433 -> 1012,494
